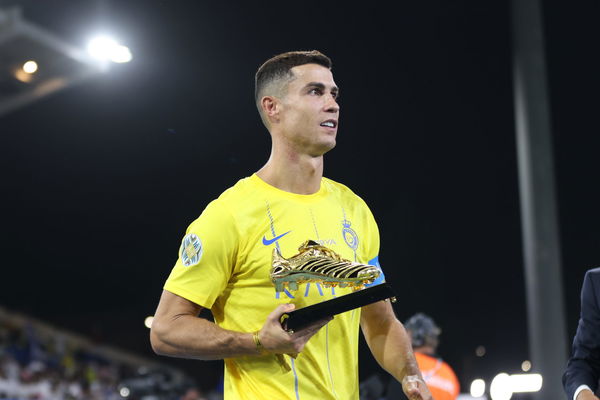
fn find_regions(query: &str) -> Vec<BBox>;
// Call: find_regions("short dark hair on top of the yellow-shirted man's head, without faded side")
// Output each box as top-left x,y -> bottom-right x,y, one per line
254,50 -> 332,104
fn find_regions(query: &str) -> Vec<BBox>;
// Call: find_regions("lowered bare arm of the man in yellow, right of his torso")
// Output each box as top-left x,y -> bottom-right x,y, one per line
360,301 -> 432,400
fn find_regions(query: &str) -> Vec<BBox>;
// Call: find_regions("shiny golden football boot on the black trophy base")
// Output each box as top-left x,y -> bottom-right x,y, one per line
271,240 -> 380,292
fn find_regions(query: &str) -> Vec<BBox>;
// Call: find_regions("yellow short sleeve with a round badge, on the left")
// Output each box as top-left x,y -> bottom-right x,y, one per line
164,199 -> 239,308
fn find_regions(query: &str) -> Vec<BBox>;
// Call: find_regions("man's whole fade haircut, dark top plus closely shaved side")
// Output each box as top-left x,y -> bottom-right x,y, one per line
254,50 -> 332,127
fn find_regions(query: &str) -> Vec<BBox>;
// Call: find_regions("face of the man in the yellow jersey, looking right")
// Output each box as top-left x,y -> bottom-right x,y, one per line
279,64 -> 340,156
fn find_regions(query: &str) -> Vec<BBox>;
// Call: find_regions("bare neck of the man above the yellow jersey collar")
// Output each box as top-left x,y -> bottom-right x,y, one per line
256,151 -> 323,194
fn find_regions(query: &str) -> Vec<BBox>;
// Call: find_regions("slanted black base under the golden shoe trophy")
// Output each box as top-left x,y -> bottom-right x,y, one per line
281,283 -> 395,332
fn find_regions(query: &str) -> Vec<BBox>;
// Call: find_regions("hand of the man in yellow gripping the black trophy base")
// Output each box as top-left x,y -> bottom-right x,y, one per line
258,304 -> 333,354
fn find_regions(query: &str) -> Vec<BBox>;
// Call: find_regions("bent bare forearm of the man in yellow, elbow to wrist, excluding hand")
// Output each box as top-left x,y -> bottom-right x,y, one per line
150,315 -> 259,360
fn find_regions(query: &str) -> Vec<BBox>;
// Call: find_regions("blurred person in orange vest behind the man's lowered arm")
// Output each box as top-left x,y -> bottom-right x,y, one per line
387,313 -> 460,400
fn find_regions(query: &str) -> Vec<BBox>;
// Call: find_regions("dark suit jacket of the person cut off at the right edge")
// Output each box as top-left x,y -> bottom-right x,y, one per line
563,268 -> 600,400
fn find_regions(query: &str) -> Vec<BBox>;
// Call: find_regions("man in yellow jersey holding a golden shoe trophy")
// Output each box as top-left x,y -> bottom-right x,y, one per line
150,51 -> 431,400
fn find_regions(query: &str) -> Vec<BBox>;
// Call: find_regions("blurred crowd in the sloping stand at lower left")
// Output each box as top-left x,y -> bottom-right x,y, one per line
0,309 -> 222,400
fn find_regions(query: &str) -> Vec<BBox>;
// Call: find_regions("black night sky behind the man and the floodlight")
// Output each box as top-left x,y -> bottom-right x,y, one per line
0,0 -> 600,390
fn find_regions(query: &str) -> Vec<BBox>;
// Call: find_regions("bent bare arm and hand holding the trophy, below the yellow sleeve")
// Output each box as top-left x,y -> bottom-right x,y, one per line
150,290 -> 329,360
